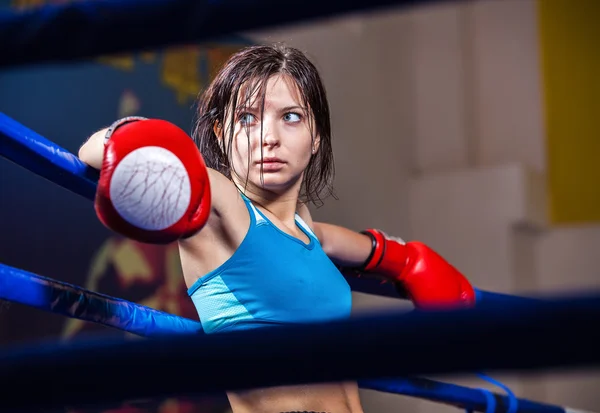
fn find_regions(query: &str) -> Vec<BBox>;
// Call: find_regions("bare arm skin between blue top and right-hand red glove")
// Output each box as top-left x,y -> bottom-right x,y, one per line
314,222 -> 373,267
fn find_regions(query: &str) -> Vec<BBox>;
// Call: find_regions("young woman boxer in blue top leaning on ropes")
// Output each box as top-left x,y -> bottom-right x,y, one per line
79,45 -> 474,413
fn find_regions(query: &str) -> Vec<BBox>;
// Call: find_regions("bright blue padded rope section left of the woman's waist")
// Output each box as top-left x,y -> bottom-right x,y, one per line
0,264 -> 202,337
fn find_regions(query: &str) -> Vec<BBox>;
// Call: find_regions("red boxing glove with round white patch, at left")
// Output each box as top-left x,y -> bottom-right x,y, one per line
95,119 -> 211,244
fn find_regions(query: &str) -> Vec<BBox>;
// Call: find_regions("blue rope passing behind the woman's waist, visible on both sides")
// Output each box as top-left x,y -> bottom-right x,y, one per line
0,264 -> 576,413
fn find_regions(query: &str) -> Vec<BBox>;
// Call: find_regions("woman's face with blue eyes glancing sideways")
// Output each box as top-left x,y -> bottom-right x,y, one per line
223,75 -> 319,199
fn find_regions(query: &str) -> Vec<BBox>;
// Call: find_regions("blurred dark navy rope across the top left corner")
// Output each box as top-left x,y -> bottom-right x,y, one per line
0,0 -> 450,67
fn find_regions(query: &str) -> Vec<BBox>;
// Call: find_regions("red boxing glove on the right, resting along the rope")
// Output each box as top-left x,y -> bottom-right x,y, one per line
362,229 -> 475,309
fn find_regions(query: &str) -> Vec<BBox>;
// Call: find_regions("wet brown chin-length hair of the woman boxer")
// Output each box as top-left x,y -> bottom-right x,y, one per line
192,43 -> 335,206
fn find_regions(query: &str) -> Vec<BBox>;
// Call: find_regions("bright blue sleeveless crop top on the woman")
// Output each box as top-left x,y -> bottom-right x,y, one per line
188,195 -> 352,333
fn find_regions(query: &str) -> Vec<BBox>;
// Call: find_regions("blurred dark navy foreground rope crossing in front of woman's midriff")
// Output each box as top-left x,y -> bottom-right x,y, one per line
0,294 -> 600,412
